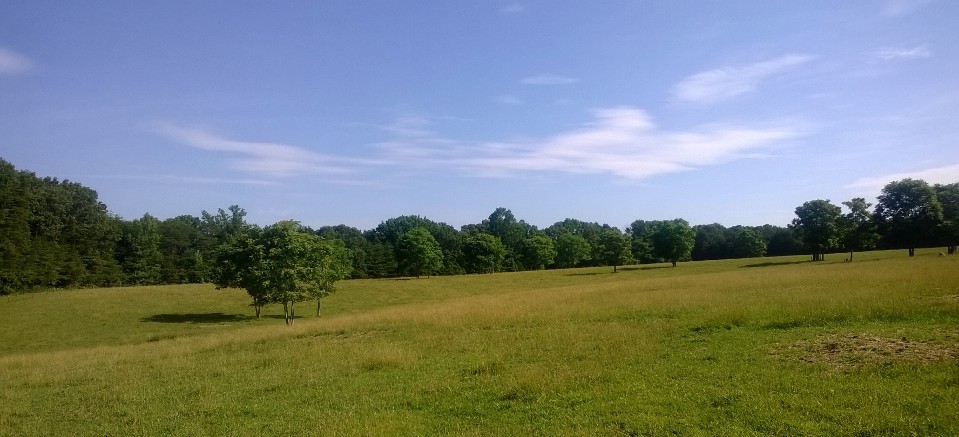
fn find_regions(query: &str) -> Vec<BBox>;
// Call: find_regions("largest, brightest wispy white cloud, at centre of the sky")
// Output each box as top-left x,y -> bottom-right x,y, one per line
381,106 -> 802,180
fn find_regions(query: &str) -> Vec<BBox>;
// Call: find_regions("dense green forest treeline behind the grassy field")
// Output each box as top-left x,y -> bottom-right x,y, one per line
0,159 -> 959,294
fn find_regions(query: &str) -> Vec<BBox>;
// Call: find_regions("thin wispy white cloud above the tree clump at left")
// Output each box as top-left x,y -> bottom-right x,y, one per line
155,123 -> 370,177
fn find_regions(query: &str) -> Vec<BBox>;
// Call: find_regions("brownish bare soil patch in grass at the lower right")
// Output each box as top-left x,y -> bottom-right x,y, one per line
770,333 -> 959,369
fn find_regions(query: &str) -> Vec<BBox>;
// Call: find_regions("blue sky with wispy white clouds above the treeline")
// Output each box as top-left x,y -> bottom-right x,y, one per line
0,0 -> 959,229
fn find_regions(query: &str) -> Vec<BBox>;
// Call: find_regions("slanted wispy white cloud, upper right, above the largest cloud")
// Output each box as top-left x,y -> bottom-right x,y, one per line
673,54 -> 814,103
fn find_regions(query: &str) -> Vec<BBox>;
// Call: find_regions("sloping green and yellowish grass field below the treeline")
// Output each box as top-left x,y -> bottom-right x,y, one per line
0,250 -> 959,435
